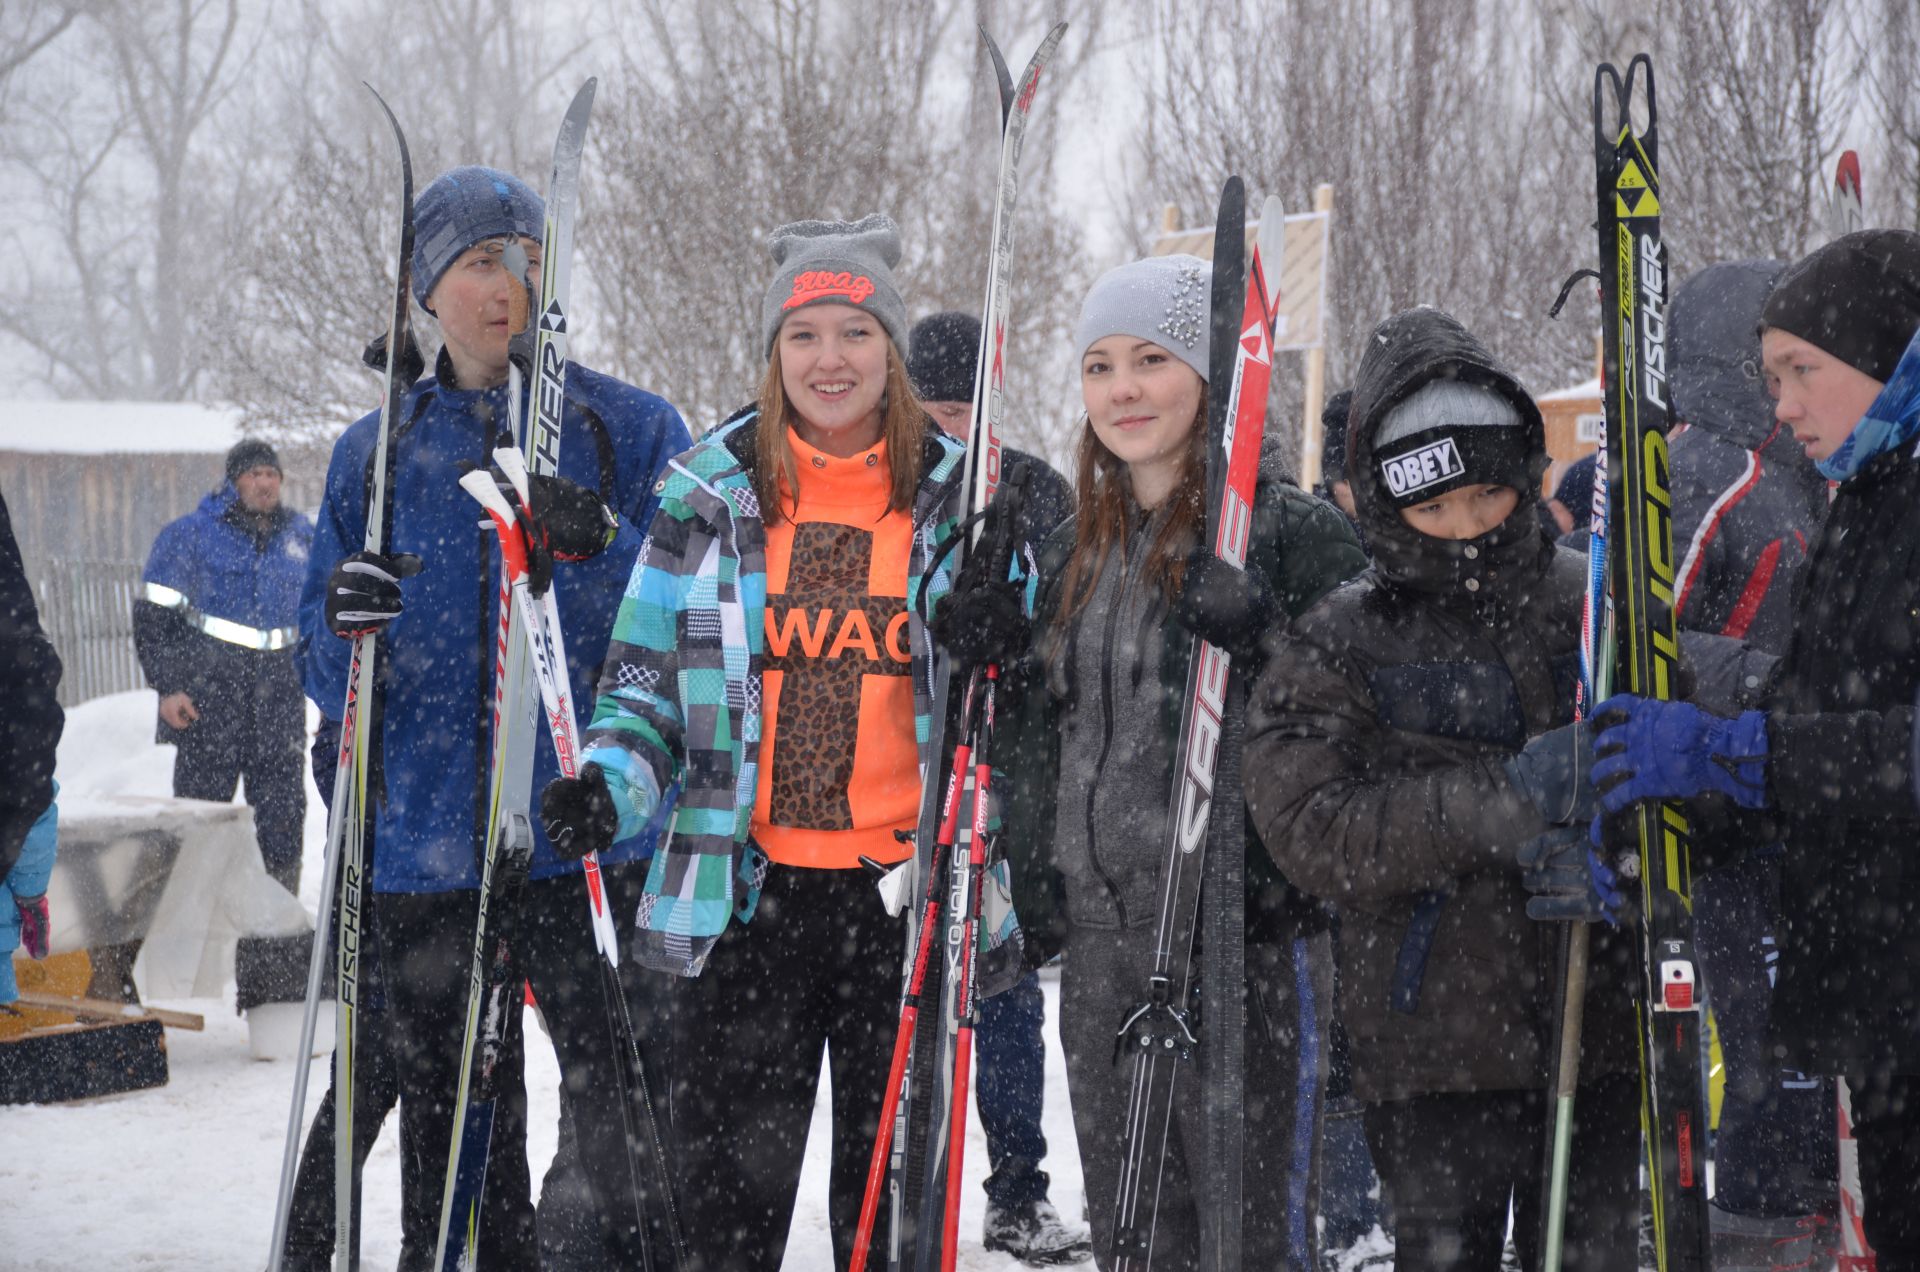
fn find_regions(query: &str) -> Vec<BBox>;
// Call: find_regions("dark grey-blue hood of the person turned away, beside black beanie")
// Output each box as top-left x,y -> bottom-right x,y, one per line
1667,259 -> 1786,450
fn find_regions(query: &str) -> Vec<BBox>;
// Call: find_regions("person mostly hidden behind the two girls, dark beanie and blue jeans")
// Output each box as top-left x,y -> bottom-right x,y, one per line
906,313 -> 1092,1264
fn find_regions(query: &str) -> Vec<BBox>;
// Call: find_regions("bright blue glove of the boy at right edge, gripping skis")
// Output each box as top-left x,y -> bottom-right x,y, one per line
1594,694 -> 1766,813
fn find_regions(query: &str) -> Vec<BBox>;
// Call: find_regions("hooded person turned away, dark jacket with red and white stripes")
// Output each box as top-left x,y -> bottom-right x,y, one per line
1667,261 -> 1837,1272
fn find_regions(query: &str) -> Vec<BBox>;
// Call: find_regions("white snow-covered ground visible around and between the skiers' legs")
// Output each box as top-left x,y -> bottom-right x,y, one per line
0,692 -> 1081,1272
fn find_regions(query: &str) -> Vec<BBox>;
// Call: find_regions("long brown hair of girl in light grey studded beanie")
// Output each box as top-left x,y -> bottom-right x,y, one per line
1058,380 -> 1208,628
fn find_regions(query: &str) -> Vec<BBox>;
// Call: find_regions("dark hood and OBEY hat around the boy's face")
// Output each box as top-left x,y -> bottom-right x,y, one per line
1346,307 -> 1553,601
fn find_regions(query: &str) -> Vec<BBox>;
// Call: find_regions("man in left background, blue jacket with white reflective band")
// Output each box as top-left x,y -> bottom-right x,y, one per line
132,438 -> 313,891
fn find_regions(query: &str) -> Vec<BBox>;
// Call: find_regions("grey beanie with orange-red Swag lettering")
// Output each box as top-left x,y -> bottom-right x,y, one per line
760,211 -> 906,357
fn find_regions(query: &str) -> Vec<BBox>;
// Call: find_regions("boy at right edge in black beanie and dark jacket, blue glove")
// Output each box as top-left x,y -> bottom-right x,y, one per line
1594,231 -> 1920,1272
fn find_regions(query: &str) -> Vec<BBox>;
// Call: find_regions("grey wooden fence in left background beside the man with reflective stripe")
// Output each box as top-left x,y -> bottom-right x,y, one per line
27,557 -> 146,707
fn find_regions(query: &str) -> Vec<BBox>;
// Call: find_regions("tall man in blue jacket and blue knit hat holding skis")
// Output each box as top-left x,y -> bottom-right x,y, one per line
288,167 -> 691,1268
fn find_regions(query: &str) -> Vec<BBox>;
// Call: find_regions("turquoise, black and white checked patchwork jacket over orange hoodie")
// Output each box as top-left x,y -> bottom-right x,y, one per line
584,411 -> 966,976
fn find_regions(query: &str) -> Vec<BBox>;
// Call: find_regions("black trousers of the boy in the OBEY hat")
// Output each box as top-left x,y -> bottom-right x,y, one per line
1365,1074 -> 1640,1272
